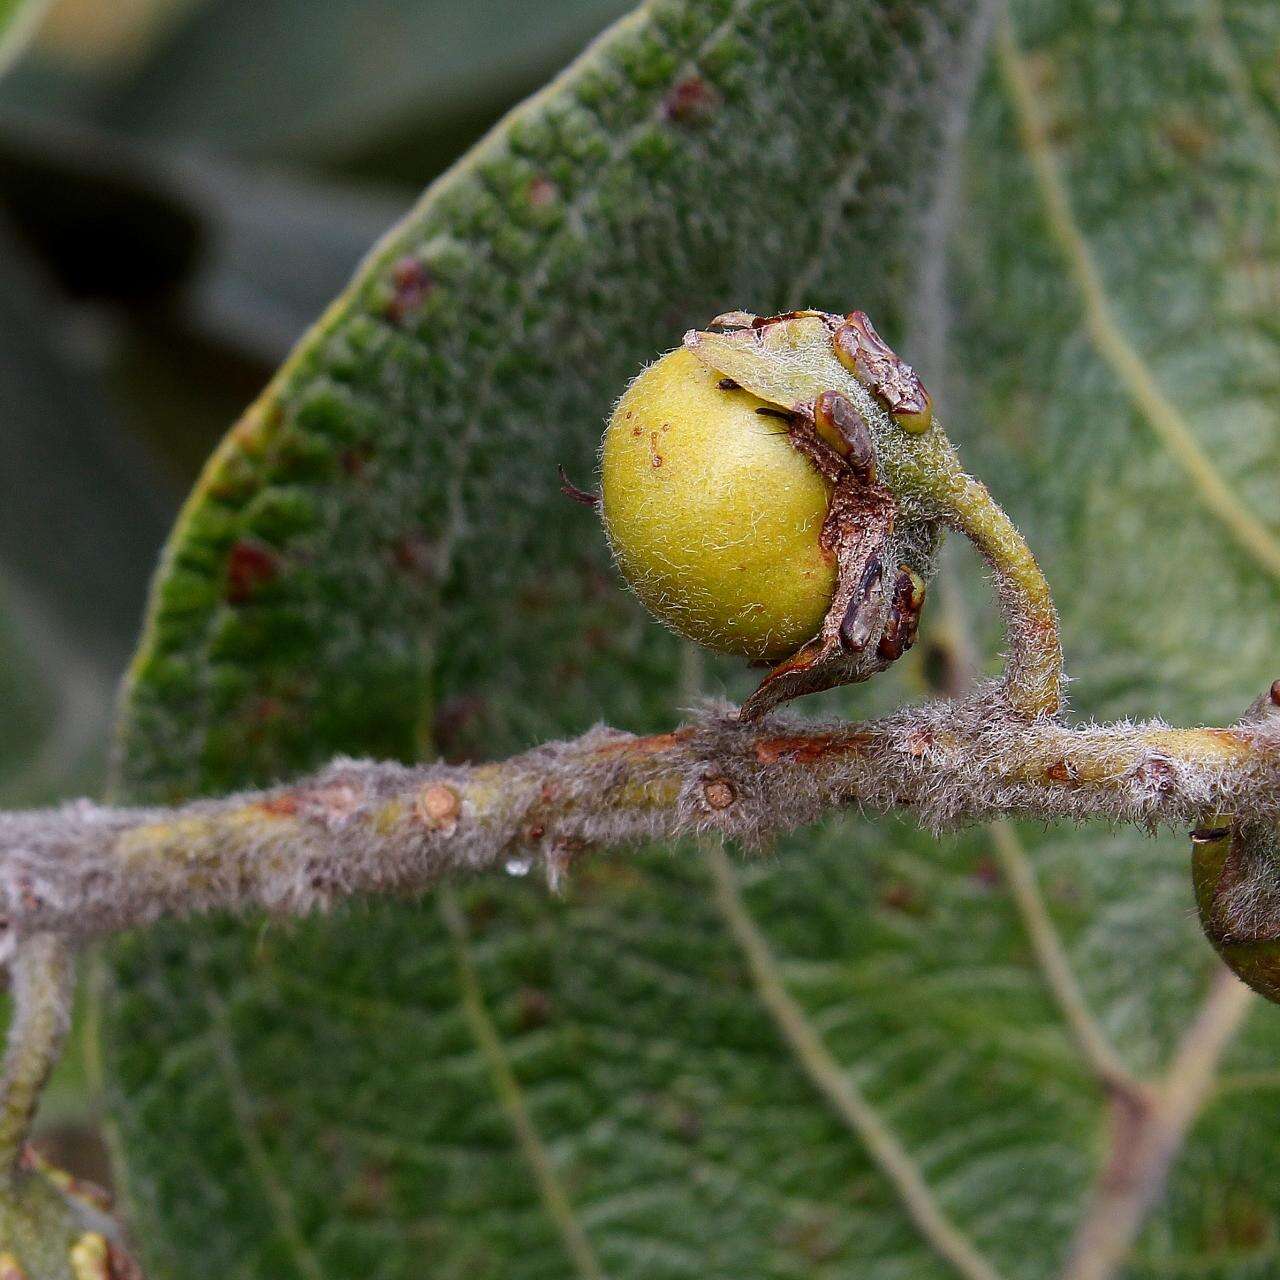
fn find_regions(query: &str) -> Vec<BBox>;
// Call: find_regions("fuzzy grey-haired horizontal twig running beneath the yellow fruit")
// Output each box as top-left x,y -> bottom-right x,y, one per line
0,685 -> 1280,947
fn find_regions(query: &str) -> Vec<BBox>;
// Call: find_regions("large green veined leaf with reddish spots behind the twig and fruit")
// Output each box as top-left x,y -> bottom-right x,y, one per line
100,0 -> 1280,1280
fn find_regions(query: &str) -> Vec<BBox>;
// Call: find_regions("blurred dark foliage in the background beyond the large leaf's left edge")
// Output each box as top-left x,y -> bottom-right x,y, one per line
0,0 -> 631,1179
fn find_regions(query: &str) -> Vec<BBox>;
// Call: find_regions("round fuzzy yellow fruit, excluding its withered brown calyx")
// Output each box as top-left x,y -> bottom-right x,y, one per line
600,349 -> 836,659
